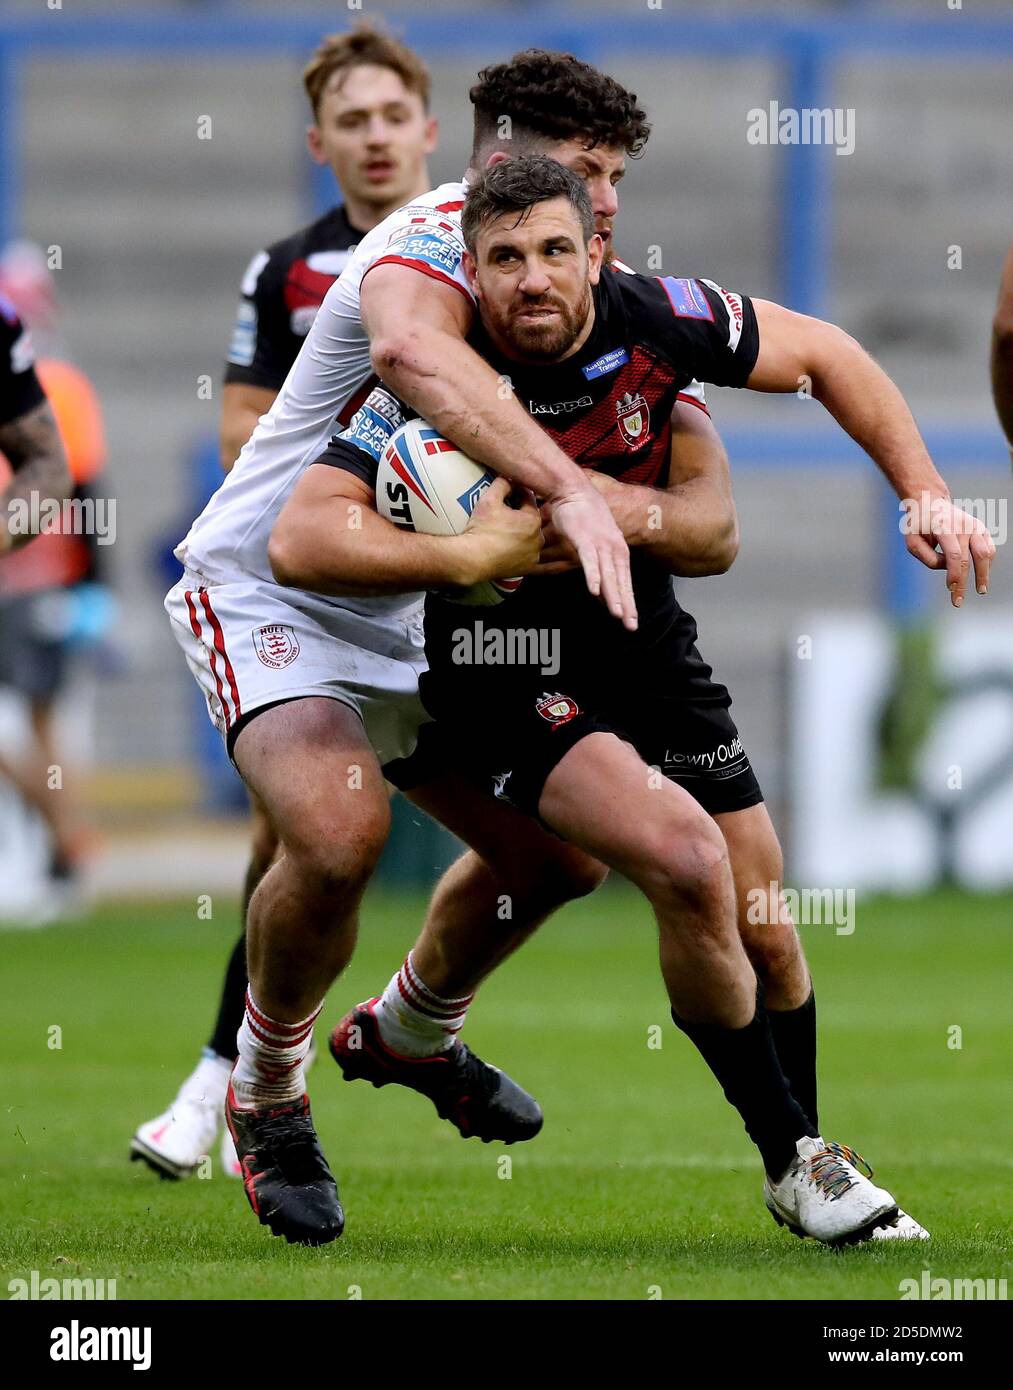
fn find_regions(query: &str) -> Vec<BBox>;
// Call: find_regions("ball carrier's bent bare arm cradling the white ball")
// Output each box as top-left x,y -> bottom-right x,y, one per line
267,463 -> 542,598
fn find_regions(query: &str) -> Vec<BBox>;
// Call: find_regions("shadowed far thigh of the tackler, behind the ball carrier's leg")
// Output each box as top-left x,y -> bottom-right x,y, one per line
404,773 -> 609,898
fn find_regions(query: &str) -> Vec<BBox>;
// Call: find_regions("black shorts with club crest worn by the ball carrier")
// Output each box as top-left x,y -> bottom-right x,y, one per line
384,614 -> 763,817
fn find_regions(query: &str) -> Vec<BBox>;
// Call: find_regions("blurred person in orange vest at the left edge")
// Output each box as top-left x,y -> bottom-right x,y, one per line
0,242 -> 108,924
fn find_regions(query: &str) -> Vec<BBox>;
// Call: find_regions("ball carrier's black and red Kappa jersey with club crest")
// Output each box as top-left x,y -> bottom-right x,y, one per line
318,266 -> 759,674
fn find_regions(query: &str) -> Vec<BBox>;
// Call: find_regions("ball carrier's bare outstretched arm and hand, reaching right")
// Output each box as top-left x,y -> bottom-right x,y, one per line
746,299 -> 995,607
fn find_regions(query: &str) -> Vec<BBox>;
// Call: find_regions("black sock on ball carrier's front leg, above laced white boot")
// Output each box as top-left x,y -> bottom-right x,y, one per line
671,988 -> 816,1177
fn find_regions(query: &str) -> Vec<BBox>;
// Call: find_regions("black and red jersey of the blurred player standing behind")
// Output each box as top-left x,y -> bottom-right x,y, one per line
225,207 -> 365,391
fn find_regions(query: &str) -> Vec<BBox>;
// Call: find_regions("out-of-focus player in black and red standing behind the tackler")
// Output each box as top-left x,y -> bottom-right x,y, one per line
131,22 -> 438,1177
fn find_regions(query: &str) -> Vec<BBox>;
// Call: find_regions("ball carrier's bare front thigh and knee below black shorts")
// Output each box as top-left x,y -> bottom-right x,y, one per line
538,731 -> 727,884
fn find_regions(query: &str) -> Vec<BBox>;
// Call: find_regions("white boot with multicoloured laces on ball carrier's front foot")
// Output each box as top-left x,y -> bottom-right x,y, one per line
763,1138 -> 898,1245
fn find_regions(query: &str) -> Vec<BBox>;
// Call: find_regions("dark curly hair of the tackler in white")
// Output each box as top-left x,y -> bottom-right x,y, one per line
468,49 -> 650,165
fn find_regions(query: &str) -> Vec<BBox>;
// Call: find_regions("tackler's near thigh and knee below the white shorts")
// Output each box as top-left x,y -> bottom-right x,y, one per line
232,696 -> 390,867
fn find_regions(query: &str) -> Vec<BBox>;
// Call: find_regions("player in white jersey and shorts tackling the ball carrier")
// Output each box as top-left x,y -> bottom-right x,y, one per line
167,56 -> 655,1240
